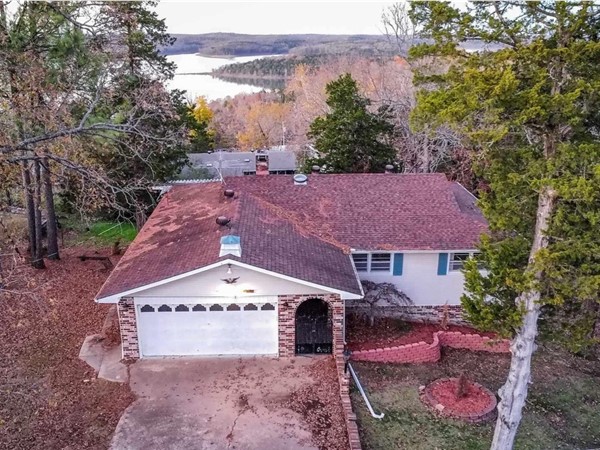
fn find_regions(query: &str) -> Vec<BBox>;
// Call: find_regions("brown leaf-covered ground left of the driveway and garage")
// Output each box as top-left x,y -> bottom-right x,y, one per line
0,247 -> 133,450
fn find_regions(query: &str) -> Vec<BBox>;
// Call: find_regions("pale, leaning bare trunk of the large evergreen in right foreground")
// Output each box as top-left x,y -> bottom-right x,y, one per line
491,187 -> 556,450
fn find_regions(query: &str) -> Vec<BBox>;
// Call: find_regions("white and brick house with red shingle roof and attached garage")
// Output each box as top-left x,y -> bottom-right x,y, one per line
96,173 -> 486,358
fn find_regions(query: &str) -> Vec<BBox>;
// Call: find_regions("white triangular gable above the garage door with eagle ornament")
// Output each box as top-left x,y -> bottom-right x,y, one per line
135,265 -> 326,297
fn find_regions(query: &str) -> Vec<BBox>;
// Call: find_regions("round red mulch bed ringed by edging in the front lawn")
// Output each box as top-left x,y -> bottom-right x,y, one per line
429,378 -> 494,416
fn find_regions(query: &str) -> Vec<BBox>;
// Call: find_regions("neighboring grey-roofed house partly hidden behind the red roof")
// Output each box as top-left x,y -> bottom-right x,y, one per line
180,147 -> 296,179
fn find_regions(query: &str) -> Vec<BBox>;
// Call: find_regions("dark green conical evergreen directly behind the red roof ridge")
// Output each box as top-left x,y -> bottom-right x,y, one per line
305,74 -> 396,173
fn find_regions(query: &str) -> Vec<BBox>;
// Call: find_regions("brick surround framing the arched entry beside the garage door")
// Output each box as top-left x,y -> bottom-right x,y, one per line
278,294 -> 344,358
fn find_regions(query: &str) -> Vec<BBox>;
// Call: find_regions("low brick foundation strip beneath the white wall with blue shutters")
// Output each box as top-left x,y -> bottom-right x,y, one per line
346,302 -> 469,325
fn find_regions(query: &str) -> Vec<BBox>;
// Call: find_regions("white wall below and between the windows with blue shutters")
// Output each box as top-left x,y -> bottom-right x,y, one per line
358,253 -> 464,305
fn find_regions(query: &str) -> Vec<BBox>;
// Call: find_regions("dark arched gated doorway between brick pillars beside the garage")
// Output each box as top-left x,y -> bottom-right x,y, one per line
296,298 -> 333,355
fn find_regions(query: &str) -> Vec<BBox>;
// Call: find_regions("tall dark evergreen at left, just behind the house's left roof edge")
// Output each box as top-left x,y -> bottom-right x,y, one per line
98,1 -> 188,228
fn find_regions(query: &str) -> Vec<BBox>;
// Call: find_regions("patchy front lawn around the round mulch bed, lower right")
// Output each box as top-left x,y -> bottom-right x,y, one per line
351,349 -> 600,450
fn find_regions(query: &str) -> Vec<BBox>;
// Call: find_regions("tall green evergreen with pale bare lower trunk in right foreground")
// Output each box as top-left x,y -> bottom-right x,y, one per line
411,1 -> 600,450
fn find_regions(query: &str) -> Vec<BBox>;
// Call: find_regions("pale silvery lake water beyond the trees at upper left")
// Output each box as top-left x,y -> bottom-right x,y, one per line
167,54 -> 278,101
